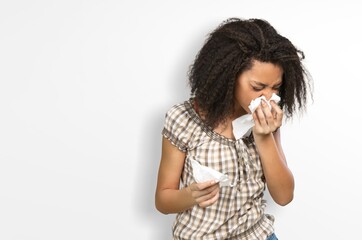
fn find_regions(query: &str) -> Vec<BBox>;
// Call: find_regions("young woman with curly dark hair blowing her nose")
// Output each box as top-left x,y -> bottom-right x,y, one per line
156,18 -> 309,240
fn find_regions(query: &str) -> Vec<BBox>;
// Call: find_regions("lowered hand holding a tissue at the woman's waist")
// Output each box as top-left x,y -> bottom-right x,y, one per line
189,180 -> 220,208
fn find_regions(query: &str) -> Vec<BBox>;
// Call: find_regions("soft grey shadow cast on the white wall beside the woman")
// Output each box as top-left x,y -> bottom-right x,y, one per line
135,22 -> 221,240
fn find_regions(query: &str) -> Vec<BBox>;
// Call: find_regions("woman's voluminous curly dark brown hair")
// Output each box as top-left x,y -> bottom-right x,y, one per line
188,18 -> 310,127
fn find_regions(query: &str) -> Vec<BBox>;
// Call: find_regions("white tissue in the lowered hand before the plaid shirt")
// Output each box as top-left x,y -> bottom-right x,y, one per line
190,159 -> 234,187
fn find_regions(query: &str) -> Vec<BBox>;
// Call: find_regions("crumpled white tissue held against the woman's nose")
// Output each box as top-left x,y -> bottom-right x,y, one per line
232,93 -> 280,139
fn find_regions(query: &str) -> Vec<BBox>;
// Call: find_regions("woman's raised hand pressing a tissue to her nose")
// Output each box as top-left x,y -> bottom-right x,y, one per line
253,100 -> 283,135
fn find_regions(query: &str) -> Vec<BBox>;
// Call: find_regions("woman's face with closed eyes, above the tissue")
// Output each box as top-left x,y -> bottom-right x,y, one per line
235,60 -> 283,115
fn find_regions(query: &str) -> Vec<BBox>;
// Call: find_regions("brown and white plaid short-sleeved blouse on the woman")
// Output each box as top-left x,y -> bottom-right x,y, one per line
162,98 -> 274,240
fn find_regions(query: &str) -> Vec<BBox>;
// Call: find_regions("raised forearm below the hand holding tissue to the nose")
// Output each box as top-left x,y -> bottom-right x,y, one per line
254,133 -> 294,205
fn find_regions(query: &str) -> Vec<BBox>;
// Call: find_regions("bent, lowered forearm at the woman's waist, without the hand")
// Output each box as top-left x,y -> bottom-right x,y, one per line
156,188 -> 196,214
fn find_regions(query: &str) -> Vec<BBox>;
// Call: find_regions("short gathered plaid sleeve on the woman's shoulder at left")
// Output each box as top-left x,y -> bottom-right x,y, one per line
162,104 -> 192,152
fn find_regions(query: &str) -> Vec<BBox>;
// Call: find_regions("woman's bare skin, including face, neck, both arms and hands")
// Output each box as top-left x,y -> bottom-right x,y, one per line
156,61 -> 294,214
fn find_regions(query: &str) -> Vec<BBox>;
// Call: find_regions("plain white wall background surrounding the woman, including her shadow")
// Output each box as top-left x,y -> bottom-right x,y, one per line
0,0 -> 362,240
